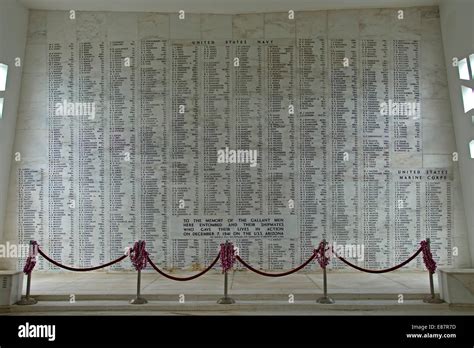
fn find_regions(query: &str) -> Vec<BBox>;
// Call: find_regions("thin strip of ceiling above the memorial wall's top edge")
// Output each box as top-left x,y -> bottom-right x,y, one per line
17,0 -> 438,14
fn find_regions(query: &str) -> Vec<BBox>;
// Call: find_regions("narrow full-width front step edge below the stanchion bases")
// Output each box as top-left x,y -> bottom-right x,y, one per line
5,300 -> 474,315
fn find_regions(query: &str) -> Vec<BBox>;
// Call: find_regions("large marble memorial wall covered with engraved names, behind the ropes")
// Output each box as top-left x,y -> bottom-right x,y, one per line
7,7 -> 466,270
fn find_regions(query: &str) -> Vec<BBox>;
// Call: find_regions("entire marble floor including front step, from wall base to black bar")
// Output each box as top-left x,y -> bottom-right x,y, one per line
0,270 -> 474,315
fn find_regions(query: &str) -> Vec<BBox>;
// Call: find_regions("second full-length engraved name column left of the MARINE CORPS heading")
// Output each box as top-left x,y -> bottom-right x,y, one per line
329,39 -> 360,267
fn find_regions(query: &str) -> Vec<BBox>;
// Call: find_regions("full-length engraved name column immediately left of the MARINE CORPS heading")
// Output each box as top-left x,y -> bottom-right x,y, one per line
360,39 -> 391,268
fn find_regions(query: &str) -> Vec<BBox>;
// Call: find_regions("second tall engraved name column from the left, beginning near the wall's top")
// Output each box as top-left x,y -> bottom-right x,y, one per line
75,42 -> 105,267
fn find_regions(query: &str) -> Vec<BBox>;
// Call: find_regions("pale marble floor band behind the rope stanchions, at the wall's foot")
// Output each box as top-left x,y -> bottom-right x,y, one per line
24,271 -> 438,296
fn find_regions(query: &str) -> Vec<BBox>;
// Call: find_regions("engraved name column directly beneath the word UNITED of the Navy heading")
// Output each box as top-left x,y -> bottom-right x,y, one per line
199,40 -> 231,264
